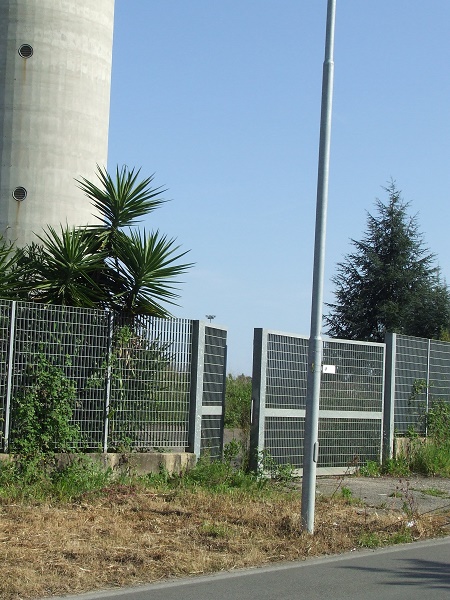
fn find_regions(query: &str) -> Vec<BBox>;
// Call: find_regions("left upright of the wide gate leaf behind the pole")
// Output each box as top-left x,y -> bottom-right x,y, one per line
249,328 -> 267,471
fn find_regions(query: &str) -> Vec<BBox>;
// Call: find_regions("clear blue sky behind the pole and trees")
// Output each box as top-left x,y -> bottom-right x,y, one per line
109,0 -> 450,374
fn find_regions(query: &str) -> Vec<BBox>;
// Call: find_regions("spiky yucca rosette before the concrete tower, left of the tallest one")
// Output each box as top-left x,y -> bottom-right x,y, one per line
31,226 -> 107,307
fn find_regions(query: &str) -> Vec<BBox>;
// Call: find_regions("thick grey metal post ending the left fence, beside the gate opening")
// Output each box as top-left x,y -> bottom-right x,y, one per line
188,321 -> 205,458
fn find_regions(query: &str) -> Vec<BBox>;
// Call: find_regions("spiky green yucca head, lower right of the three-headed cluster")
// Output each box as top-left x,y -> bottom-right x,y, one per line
112,231 -> 192,317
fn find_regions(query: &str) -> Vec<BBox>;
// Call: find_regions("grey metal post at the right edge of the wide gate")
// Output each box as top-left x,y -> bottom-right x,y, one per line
382,333 -> 397,463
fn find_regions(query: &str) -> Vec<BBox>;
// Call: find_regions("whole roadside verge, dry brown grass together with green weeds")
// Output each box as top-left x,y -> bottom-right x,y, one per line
0,456 -> 446,600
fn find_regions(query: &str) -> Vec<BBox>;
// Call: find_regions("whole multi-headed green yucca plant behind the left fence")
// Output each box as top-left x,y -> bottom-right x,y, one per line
14,167 -> 192,319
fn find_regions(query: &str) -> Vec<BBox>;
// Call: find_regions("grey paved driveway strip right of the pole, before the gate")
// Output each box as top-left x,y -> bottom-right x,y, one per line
316,476 -> 450,514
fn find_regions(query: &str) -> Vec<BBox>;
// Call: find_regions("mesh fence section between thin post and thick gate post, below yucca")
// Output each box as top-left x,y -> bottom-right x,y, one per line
109,317 -> 192,450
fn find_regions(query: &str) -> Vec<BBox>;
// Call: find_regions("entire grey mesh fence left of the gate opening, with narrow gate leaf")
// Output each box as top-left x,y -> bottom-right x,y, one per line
0,300 -> 226,455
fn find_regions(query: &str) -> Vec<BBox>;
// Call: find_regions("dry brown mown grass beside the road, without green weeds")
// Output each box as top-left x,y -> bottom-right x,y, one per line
0,484 -> 445,600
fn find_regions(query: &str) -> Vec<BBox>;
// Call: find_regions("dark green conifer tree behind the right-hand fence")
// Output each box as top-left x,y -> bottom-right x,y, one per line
325,181 -> 450,342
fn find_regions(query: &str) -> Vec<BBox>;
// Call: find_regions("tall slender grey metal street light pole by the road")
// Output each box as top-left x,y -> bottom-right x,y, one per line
301,0 -> 336,533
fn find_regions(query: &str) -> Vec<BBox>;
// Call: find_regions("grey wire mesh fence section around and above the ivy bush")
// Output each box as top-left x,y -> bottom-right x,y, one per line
13,303 -> 108,448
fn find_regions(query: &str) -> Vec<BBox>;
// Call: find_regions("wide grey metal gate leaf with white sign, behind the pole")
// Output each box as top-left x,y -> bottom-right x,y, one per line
251,329 -> 385,472
